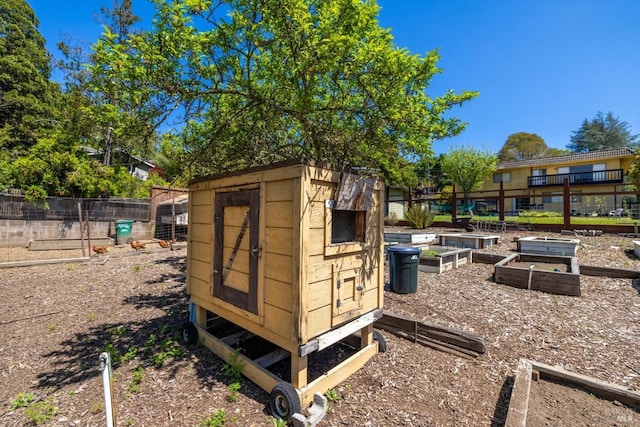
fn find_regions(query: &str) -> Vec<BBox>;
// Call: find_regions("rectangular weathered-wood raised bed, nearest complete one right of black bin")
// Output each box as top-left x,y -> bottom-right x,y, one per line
493,254 -> 580,296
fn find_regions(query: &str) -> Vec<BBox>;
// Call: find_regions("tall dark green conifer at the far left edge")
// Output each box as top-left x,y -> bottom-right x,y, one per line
0,0 -> 59,156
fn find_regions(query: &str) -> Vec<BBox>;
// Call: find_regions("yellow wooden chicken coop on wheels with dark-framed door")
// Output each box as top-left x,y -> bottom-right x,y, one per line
183,160 -> 385,419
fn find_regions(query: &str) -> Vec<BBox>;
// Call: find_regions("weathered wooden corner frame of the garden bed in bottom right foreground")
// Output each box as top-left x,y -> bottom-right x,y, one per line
505,359 -> 640,427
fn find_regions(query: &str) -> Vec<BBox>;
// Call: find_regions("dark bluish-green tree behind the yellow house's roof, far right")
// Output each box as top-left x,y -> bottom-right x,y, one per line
567,112 -> 639,153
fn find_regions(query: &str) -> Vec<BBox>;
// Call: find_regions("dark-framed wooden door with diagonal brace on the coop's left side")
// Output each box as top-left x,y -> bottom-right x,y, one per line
213,188 -> 260,314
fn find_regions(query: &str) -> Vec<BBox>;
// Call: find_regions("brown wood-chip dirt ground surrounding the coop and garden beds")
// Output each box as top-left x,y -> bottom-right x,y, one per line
0,230 -> 640,426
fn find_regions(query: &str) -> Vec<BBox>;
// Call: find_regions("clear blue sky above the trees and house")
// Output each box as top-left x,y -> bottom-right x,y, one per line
27,0 -> 640,154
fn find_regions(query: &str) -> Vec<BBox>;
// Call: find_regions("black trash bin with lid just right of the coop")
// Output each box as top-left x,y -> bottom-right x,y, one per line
387,246 -> 420,294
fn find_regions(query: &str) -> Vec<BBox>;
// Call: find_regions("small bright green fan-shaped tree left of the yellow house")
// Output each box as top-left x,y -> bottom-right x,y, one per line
441,147 -> 498,198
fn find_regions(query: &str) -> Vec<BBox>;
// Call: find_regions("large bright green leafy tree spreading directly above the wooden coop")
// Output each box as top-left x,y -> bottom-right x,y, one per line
89,0 -> 477,179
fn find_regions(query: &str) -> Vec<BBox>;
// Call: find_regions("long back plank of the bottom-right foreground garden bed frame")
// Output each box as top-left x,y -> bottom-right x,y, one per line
528,360 -> 640,408
